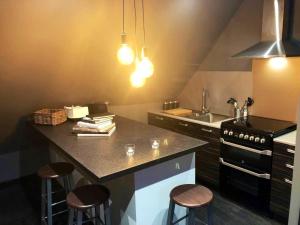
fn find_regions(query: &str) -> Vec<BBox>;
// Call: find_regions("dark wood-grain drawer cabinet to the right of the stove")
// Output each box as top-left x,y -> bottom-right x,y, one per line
270,142 -> 295,221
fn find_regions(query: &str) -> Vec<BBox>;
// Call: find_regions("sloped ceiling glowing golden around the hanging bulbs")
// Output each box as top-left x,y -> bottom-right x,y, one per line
0,0 -> 246,144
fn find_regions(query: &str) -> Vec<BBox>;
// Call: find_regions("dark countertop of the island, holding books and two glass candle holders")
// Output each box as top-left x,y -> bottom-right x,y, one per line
33,116 -> 206,182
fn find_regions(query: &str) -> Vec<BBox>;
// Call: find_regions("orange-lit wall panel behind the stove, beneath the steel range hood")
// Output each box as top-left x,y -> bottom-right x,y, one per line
253,57 -> 300,121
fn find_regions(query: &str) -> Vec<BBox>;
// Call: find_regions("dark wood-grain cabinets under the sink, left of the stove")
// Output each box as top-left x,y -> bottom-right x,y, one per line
148,113 -> 220,187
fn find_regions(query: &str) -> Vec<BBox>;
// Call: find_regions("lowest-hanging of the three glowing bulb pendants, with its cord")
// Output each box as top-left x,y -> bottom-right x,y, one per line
130,0 -> 145,88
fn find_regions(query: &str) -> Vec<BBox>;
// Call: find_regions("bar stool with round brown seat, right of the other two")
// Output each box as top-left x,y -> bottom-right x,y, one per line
167,184 -> 213,225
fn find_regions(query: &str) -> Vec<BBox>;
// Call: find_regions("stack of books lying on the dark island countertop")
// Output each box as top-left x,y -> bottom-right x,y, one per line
73,113 -> 116,137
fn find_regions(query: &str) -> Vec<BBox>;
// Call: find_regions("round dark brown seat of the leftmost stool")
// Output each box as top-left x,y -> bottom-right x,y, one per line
38,162 -> 74,179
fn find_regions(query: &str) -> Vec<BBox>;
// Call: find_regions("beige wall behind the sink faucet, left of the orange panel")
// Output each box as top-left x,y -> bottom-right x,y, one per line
178,71 -> 255,115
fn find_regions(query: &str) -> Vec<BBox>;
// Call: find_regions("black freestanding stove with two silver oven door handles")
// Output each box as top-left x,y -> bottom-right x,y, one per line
220,116 -> 296,209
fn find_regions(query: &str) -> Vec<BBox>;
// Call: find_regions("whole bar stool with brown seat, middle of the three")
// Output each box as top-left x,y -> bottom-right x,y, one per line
67,184 -> 111,225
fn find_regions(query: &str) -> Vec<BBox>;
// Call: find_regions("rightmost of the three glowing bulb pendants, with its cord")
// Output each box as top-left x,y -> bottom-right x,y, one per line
138,0 -> 154,78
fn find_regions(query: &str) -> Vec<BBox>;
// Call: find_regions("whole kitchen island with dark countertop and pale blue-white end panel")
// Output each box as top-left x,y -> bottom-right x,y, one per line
33,116 -> 206,225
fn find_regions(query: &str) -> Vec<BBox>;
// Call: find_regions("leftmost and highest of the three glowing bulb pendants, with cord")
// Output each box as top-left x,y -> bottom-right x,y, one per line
117,0 -> 134,65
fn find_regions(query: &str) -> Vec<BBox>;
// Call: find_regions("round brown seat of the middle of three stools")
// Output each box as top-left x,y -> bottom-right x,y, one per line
67,184 -> 110,209
